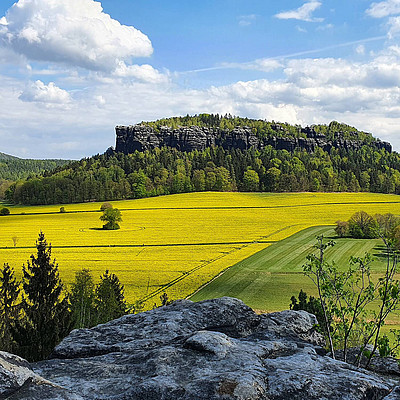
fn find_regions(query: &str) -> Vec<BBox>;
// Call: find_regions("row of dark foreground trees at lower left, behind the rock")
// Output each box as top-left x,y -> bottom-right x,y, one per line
0,233 -> 127,361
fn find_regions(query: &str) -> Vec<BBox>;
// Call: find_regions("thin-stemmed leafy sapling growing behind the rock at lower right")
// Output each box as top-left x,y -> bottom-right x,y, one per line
303,236 -> 400,367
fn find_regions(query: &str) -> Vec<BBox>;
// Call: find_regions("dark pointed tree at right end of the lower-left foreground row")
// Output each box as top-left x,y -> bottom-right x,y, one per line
95,270 -> 127,324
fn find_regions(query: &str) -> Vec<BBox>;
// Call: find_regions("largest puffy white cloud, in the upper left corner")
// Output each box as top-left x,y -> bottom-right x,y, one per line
0,0 -> 153,71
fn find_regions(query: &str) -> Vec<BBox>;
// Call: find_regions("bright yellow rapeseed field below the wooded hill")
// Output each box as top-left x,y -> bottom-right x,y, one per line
0,192 -> 400,310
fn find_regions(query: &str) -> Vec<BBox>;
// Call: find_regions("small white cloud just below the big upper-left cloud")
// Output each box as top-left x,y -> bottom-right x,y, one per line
19,80 -> 71,107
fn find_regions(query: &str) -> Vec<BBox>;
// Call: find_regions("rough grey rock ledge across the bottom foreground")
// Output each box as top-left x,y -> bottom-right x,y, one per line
0,297 -> 400,400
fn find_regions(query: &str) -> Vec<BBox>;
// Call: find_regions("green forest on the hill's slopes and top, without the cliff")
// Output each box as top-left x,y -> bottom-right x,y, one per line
7,114 -> 400,204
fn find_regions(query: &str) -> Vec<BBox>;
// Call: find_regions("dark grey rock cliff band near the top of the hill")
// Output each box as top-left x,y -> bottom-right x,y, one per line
116,125 -> 392,154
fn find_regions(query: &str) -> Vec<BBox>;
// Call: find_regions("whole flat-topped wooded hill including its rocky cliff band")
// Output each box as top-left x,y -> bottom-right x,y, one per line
5,114 -> 400,204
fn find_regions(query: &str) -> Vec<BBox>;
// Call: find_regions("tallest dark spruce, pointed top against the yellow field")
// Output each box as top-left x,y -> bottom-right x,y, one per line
14,232 -> 71,361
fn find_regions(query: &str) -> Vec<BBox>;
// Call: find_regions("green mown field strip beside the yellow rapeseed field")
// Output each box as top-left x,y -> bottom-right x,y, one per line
192,226 -> 386,311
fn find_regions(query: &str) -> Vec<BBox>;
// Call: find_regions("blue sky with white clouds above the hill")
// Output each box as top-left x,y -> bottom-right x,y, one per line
0,0 -> 400,159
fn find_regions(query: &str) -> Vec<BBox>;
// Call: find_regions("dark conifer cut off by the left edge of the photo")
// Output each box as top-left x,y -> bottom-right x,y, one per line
0,264 -> 20,353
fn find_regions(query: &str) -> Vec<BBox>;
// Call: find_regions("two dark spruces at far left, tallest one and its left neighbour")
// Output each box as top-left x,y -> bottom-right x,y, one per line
0,232 -> 71,361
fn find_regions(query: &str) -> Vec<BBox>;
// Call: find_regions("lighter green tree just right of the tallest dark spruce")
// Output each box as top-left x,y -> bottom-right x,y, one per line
69,269 -> 96,328
